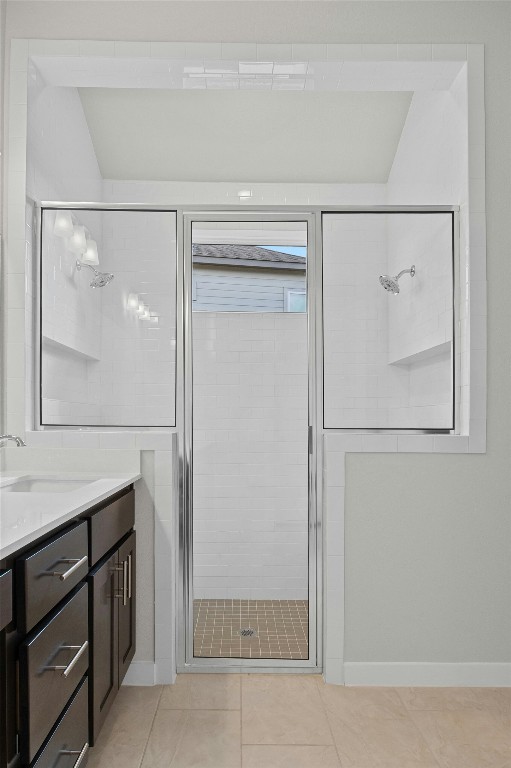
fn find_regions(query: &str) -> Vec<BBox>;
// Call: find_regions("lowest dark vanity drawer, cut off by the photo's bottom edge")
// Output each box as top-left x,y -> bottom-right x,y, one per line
32,678 -> 89,768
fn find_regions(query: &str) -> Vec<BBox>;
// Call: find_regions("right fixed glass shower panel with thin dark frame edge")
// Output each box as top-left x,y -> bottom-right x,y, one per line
323,213 -> 454,430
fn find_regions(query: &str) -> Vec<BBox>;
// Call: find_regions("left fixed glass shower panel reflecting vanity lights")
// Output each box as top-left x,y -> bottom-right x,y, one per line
41,209 -> 176,427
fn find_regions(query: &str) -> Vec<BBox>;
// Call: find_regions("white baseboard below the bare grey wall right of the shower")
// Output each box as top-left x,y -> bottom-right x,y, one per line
344,661 -> 511,688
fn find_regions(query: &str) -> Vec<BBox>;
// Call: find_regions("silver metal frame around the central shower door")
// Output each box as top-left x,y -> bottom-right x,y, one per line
177,206 -> 323,672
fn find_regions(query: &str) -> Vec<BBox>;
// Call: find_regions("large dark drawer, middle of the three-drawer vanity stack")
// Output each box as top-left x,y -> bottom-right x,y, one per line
19,584 -> 89,764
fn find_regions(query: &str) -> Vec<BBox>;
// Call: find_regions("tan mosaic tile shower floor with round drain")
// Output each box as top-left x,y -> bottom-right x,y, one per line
193,600 -> 309,659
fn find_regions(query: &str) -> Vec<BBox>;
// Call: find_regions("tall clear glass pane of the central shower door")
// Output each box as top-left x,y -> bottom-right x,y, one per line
192,222 -> 309,659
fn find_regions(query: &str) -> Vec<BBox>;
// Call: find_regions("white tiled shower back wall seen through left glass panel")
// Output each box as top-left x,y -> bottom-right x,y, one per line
98,211 -> 176,427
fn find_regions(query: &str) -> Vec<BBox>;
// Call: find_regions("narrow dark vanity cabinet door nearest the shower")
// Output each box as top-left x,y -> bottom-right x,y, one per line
117,531 -> 136,685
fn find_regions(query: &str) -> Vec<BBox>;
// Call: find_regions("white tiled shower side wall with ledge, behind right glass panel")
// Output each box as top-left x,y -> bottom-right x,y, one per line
387,213 -> 454,429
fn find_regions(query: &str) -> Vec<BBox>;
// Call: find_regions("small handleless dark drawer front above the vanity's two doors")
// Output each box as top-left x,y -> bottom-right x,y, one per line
89,490 -> 135,565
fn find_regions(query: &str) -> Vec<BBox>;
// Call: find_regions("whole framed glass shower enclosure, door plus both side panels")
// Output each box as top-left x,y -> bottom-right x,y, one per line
38,203 -> 460,671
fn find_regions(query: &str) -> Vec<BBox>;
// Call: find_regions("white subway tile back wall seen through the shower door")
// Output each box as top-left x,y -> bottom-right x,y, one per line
193,312 -> 308,600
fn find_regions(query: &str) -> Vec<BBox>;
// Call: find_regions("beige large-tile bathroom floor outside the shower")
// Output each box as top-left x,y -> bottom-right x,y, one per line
88,674 -> 511,768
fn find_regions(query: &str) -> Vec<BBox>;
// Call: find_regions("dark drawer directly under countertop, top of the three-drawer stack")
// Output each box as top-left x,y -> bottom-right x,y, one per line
16,522 -> 89,634
